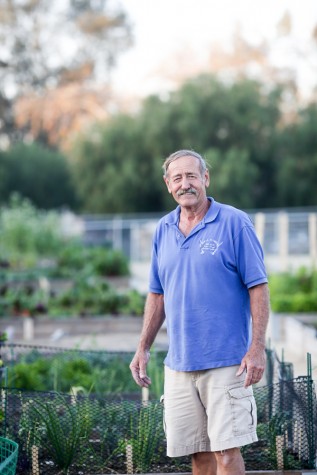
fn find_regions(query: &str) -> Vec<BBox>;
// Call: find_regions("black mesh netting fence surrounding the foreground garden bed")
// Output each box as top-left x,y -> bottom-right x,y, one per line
0,345 -> 317,475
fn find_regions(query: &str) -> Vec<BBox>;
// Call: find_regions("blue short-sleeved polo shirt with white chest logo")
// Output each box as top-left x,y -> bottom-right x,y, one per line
149,198 -> 267,371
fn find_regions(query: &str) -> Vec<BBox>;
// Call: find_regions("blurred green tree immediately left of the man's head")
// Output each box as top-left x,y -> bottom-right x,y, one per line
71,115 -> 163,213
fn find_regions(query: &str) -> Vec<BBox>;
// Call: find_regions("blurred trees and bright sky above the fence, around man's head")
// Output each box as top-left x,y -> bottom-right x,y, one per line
0,0 -> 317,214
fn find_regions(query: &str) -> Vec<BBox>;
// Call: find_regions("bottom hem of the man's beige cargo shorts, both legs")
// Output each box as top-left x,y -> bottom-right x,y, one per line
167,432 -> 258,457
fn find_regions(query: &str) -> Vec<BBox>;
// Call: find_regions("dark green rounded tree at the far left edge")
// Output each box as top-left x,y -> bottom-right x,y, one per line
0,143 -> 78,209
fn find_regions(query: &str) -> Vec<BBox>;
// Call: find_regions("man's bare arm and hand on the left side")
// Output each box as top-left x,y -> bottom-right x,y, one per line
130,292 -> 165,388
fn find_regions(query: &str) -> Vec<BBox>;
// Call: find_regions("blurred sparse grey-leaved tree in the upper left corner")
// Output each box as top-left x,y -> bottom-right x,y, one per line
0,0 -> 131,145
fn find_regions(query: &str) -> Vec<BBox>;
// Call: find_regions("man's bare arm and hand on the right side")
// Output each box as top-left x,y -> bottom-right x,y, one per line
237,284 -> 270,387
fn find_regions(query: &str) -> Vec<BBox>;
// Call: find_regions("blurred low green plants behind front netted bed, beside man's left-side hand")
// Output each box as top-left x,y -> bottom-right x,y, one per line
3,349 -> 164,399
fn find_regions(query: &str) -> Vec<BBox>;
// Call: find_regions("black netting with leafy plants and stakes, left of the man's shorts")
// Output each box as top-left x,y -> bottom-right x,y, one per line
1,389 -> 188,475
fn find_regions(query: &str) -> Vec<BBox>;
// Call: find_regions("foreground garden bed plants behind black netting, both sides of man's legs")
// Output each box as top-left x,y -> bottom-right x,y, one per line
0,385 -> 313,475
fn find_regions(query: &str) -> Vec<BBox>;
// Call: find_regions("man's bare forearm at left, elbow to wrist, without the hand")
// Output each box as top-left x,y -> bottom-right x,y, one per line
138,292 -> 165,351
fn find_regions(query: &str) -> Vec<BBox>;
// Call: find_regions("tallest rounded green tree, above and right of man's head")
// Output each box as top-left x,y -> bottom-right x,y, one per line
148,75 -> 284,208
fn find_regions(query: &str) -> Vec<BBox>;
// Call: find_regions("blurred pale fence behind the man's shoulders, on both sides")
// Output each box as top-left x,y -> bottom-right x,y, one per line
83,210 -> 317,271
